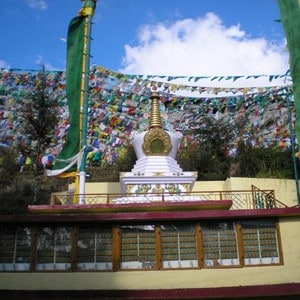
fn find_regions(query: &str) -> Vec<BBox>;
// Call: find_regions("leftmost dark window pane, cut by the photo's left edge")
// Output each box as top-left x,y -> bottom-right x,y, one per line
0,227 -> 31,271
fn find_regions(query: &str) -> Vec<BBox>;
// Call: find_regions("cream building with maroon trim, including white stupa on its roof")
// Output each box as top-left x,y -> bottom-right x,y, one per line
0,93 -> 300,299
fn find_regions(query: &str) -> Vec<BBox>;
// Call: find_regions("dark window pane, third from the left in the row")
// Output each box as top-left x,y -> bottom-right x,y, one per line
77,227 -> 112,270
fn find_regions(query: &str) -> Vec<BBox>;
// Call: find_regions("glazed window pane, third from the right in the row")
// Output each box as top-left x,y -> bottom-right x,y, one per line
161,224 -> 198,268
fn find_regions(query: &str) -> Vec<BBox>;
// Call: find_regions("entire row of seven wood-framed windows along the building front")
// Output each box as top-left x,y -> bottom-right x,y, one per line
0,218 -> 283,272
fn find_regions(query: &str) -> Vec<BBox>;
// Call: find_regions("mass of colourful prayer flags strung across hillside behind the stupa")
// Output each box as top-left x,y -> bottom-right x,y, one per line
0,65 -> 296,166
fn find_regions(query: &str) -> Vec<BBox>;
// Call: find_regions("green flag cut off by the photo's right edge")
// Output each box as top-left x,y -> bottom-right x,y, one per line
278,0 -> 300,144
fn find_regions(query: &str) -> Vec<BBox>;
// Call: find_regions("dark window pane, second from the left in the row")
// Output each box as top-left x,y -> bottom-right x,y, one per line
36,227 -> 71,271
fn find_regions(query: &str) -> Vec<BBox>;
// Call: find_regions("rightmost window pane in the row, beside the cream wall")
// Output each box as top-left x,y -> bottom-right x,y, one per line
242,220 -> 280,265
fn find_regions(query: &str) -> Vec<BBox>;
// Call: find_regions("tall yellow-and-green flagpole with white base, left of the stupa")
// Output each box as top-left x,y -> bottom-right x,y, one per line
78,0 -> 97,204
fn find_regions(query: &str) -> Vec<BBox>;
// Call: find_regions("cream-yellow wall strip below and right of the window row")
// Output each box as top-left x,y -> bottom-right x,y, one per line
0,217 -> 300,290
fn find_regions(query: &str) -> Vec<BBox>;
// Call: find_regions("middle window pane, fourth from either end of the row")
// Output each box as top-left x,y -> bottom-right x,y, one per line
121,225 -> 156,269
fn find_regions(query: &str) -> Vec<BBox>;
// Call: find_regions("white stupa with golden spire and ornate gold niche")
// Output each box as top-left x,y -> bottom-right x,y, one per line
120,92 -> 197,200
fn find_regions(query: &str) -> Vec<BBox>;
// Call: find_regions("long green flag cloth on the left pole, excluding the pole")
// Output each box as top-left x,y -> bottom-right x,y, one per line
47,16 -> 85,176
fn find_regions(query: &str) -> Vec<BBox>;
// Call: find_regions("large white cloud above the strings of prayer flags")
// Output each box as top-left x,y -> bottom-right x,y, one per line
121,13 -> 289,86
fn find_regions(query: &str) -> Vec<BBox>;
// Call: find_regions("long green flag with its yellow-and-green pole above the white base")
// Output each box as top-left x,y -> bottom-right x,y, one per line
46,0 -> 97,177
